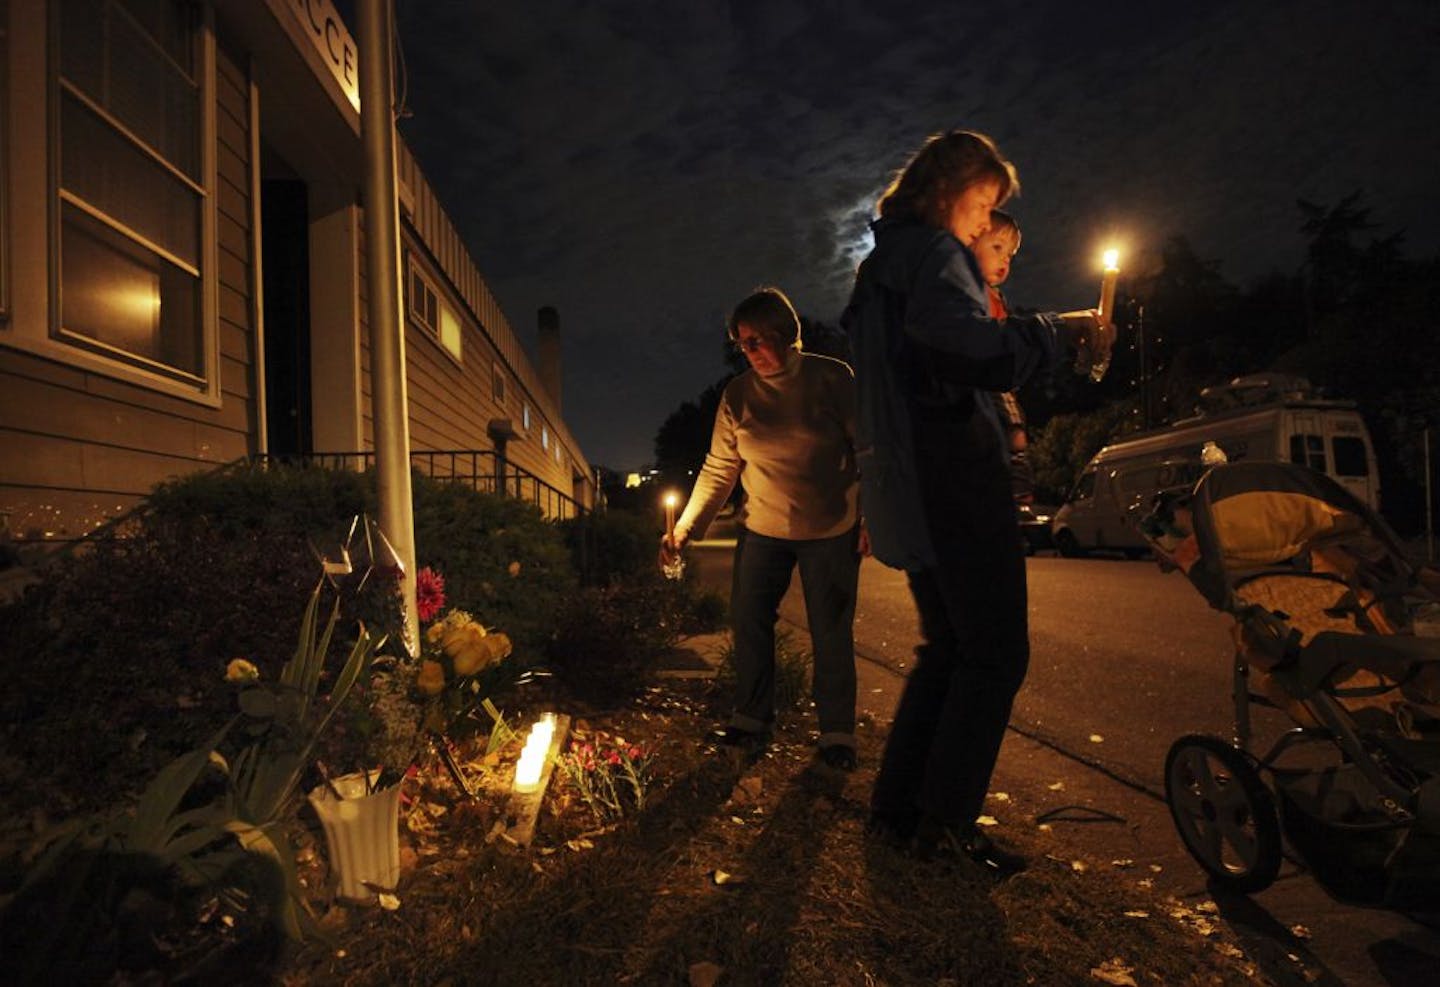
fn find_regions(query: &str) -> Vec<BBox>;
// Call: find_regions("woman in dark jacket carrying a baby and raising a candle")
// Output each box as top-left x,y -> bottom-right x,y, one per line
842,131 -> 1115,873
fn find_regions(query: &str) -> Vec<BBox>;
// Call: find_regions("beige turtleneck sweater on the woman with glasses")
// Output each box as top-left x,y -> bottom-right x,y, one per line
675,350 -> 860,540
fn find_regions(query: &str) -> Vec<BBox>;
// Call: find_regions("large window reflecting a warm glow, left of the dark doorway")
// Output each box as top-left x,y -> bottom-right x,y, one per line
56,0 -> 212,388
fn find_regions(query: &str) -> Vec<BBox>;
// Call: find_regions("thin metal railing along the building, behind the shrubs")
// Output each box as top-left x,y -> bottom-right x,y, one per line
249,450 -> 588,520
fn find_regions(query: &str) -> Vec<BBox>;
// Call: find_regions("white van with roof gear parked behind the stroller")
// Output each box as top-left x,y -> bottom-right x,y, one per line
1051,376 -> 1380,555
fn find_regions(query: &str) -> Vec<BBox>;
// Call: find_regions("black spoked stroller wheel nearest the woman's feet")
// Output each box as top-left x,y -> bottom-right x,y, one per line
1165,733 -> 1280,893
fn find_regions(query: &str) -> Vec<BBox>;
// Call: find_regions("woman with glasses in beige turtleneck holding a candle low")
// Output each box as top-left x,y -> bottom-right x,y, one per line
660,288 -> 863,771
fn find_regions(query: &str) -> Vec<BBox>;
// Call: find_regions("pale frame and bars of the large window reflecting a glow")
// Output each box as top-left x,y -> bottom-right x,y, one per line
40,3 -> 222,408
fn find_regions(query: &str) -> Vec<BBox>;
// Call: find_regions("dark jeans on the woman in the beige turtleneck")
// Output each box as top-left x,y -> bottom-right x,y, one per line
730,529 -> 860,746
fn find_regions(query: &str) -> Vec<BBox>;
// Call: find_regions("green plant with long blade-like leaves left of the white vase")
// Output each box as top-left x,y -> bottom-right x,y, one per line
0,582 -> 382,980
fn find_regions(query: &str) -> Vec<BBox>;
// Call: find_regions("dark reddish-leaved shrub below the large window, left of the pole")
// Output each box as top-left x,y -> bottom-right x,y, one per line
0,517 -> 395,808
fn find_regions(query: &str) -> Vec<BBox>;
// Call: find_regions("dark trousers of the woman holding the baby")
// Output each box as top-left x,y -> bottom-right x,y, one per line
871,414 -> 1030,826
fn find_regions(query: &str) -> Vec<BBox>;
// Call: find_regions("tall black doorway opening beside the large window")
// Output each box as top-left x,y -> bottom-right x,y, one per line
261,170 -> 314,455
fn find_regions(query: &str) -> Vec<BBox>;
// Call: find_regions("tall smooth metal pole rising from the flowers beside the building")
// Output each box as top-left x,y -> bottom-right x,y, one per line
359,0 -> 419,656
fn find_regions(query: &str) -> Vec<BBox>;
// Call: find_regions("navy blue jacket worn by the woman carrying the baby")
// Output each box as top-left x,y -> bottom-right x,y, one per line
841,219 -> 1060,571
